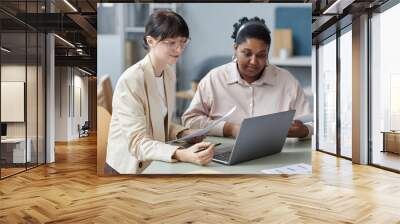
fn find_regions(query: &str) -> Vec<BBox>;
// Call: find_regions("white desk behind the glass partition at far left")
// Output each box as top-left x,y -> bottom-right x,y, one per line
1,138 -> 32,163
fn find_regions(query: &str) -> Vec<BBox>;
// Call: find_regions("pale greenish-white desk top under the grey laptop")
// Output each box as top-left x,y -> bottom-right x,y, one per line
143,137 -> 311,174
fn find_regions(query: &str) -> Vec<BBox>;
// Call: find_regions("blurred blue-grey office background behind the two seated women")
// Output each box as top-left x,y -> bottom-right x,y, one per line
97,3 -> 313,118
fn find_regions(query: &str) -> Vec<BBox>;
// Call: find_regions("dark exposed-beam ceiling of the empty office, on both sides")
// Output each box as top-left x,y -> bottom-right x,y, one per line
0,0 -> 394,73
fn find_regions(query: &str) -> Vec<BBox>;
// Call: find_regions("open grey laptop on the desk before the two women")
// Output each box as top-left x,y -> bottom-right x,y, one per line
213,110 -> 296,165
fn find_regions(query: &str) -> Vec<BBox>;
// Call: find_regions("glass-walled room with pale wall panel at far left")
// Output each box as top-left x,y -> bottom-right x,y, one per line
0,12 -> 46,177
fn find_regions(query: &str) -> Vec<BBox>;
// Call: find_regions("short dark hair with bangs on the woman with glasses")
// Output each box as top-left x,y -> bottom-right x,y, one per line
143,10 -> 189,50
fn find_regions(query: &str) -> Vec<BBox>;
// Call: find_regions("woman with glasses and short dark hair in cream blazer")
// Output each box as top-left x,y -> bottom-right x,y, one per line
106,10 -> 214,174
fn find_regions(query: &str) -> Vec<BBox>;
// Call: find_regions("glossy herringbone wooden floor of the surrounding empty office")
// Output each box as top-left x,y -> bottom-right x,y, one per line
0,134 -> 400,224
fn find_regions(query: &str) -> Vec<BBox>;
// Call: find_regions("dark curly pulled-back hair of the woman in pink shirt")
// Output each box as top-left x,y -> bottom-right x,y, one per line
231,16 -> 271,46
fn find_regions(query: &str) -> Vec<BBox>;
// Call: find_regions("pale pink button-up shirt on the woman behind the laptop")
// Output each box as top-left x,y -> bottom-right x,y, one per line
182,62 -> 313,137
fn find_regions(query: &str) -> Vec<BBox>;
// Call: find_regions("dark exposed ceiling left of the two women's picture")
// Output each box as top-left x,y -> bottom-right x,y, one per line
0,0 -> 97,74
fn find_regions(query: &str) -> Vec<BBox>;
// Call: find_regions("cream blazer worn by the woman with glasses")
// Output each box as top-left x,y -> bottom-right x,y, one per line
106,55 -> 188,174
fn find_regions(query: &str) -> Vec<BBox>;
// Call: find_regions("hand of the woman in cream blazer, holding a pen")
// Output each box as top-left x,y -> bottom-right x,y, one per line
173,142 -> 215,166
